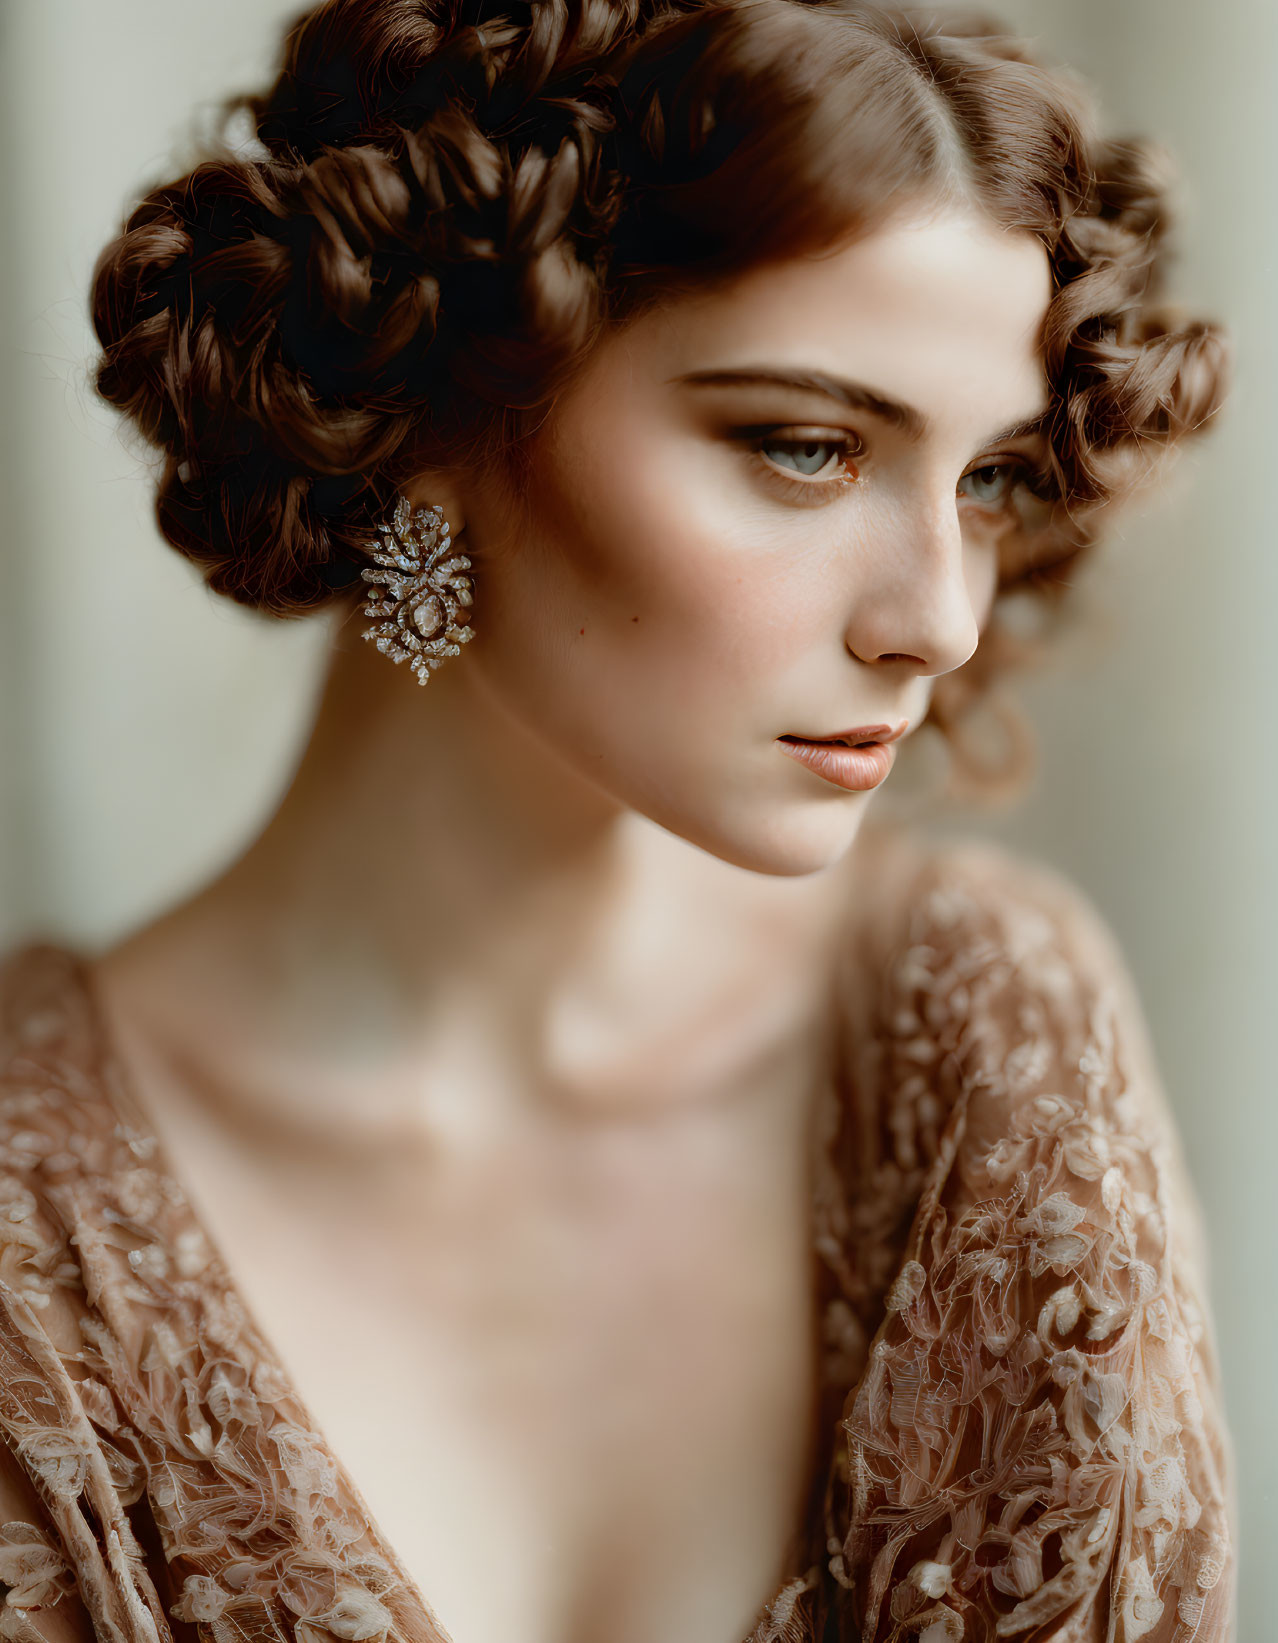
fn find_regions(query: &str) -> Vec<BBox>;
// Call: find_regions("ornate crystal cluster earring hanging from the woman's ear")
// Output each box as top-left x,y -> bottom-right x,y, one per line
360,496 -> 475,685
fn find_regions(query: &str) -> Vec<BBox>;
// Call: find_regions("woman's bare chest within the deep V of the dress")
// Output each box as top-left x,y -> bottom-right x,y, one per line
142,1068 -> 827,1643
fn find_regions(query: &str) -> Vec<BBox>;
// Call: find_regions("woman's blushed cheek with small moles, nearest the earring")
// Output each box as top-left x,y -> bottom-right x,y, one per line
476,419 -> 811,734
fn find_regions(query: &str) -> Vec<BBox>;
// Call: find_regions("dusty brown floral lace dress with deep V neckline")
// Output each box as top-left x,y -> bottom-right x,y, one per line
0,841 -> 1235,1643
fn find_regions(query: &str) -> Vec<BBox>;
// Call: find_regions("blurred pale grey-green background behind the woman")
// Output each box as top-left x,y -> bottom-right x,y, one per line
0,0 -> 1278,1623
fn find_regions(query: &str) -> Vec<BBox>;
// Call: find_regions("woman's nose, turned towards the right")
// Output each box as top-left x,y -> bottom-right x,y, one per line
846,493 -> 984,677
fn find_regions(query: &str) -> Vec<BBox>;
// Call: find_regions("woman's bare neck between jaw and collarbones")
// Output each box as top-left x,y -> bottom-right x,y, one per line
100,624 -> 839,1150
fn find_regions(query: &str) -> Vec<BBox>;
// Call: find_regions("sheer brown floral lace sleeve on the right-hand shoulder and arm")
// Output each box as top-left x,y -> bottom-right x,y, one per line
831,843 -> 1235,1643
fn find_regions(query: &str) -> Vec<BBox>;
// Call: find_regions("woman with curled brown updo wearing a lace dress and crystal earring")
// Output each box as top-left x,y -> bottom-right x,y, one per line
0,0 -> 1234,1643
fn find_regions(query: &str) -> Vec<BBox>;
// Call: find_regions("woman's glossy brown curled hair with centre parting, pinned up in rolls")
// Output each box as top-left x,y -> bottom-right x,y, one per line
92,0 -> 1225,795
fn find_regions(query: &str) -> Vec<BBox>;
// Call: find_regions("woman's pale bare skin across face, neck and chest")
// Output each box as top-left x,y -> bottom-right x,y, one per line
84,210 -> 1051,1643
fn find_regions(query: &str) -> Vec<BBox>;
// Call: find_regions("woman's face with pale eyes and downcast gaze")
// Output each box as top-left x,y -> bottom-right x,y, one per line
425,214 -> 1051,874
